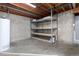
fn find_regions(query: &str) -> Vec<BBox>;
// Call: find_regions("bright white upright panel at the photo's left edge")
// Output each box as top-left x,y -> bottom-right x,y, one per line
0,18 -> 10,52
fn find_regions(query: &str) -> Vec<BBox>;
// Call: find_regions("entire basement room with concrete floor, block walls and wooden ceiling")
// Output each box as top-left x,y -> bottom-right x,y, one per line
0,3 -> 79,56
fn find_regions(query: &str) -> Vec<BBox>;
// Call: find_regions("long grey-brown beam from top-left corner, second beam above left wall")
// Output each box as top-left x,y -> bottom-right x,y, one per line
0,3 -> 41,18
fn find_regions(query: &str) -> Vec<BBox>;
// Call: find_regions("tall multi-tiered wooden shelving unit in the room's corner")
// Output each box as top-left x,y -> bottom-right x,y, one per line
31,15 -> 58,42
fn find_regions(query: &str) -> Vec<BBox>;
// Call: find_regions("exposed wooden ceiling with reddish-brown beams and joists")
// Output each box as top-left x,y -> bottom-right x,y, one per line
0,3 -> 79,19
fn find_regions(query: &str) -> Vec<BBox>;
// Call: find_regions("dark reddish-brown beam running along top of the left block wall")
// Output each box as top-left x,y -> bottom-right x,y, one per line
0,6 -> 40,19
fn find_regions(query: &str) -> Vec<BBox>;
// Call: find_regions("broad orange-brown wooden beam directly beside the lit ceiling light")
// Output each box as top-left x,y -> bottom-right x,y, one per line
10,3 -> 45,17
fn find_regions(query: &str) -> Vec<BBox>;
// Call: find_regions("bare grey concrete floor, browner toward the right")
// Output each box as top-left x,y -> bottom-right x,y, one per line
0,39 -> 79,56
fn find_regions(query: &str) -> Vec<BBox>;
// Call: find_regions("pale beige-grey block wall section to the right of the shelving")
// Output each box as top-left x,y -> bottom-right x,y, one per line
58,12 -> 74,44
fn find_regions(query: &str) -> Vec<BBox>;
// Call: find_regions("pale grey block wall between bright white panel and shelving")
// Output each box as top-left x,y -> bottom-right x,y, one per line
0,12 -> 31,42
